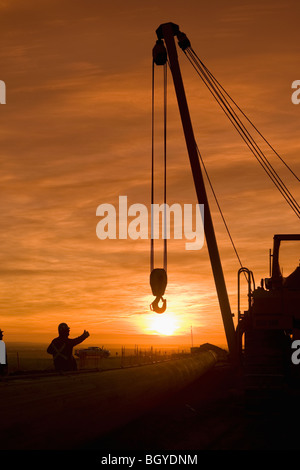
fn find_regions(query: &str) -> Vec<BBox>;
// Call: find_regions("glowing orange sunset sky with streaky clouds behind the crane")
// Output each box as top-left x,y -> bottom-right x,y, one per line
0,0 -> 300,346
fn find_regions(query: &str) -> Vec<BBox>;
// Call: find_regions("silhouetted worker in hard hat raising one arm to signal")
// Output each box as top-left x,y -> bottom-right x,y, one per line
47,323 -> 90,372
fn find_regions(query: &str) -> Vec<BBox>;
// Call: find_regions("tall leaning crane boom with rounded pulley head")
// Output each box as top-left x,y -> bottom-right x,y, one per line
156,23 -> 237,360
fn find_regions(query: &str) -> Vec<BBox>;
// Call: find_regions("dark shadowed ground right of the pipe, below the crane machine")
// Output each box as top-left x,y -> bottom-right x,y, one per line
82,361 -> 300,452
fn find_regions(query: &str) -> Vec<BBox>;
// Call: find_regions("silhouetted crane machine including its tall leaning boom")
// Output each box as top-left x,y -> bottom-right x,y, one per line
153,23 -> 300,389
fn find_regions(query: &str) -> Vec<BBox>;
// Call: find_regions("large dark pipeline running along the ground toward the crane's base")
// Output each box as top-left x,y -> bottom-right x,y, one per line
0,351 -> 217,450
